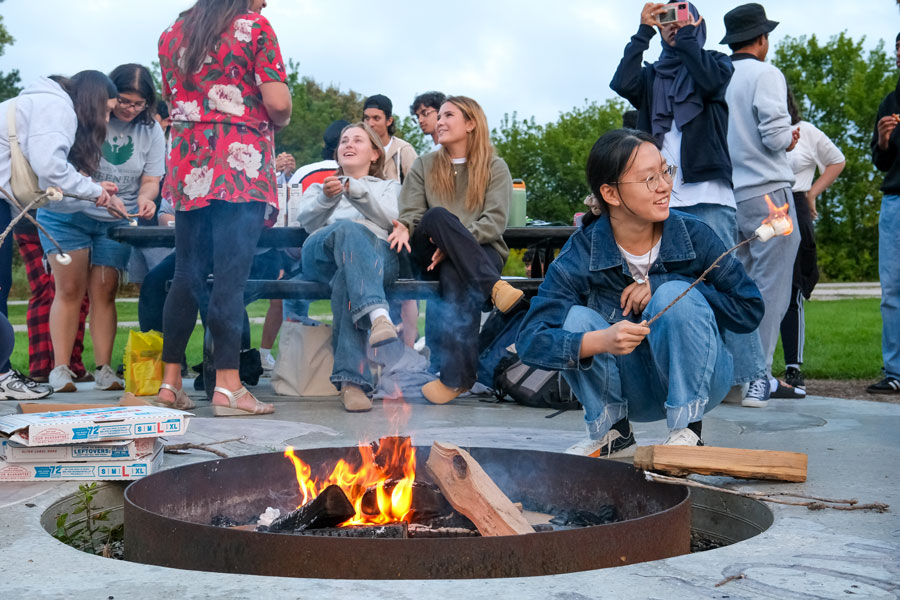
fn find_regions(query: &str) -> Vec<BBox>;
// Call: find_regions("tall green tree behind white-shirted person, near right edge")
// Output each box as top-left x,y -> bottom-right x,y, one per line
773,32 -> 897,281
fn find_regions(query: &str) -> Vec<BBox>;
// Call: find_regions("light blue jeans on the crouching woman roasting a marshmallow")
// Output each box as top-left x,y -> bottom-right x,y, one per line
562,281 -> 733,439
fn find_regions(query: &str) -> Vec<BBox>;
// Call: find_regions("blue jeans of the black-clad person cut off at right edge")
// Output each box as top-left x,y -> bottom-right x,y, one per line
878,195 -> 900,379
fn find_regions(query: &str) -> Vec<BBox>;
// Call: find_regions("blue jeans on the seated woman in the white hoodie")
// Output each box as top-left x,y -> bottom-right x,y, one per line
302,221 -> 399,392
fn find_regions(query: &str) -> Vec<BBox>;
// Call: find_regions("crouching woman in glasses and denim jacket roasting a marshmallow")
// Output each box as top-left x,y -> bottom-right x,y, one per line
516,129 -> 764,457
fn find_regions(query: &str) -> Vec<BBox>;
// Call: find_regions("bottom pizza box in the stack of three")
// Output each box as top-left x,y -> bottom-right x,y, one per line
0,439 -> 163,482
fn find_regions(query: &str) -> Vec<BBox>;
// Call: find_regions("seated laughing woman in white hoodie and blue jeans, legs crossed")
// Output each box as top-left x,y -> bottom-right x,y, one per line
297,123 -> 400,412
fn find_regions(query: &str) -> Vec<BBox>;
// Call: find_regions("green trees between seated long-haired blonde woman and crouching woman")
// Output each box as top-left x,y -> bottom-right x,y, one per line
492,100 -> 625,224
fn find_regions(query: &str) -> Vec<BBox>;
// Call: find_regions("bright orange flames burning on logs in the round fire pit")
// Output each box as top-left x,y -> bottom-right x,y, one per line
284,437 -> 416,526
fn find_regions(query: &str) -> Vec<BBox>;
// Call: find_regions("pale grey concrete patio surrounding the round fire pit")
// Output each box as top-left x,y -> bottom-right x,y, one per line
0,380 -> 900,600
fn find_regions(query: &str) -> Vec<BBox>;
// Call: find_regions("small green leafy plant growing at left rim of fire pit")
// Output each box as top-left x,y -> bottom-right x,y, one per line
53,482 -> 125,557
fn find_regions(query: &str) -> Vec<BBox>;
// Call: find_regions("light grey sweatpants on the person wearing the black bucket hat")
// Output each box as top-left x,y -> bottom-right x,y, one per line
737,187 -> 800,377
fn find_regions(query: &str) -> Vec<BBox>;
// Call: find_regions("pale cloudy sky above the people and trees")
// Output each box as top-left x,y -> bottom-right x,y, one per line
0,0 -> 900,127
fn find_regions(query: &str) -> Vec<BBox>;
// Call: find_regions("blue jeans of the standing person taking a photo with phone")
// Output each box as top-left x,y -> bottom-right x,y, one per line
675,203 -> 766,385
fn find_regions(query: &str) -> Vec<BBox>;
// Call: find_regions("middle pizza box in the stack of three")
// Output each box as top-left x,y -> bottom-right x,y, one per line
0,438 -> 159,463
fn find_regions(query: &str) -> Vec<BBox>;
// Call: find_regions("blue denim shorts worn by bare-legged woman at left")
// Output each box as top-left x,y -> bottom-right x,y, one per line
37,209 -> 131,271
